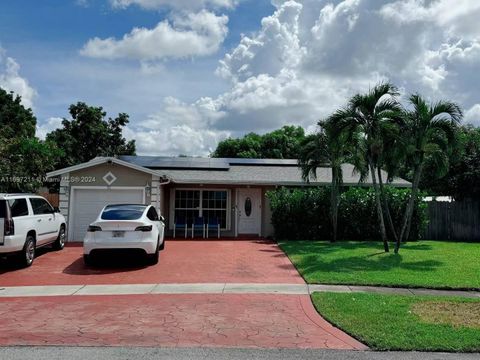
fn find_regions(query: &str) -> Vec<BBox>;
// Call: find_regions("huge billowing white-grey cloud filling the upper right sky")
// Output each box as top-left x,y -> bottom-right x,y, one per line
128,0 -> 480,154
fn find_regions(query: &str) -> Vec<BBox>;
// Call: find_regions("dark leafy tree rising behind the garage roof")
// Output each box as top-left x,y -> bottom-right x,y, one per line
47,102 -> 135,167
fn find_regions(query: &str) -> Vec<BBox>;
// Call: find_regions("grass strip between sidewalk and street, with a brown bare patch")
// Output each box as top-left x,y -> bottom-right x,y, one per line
312,293 -> 480,352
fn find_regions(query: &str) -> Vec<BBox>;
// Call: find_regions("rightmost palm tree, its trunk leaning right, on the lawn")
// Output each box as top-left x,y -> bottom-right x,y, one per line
395,94 -> 463,253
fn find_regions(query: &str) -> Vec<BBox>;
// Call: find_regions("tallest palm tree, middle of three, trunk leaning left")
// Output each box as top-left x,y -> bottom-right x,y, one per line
330,83 -> 401,252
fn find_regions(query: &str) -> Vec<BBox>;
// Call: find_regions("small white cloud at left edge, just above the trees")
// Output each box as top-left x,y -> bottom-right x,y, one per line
0,47 -> 37,108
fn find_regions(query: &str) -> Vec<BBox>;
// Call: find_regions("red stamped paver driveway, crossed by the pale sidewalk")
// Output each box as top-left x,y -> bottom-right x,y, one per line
0,241 -> 365,349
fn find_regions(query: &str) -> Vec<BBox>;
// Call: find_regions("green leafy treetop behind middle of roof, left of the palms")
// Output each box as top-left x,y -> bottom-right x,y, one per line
211,126 -> 305,159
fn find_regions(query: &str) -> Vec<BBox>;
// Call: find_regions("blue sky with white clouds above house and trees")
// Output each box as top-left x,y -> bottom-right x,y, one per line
0,0 -> 480,156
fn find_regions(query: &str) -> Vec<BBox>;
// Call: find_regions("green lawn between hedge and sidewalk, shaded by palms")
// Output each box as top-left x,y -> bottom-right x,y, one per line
279,241 -> 480,289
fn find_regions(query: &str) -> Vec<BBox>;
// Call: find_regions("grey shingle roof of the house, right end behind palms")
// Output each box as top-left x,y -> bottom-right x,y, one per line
47,156 -> 410,187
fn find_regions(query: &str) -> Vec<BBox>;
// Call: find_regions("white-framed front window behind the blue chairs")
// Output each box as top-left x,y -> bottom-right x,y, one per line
174,190 -> 228,229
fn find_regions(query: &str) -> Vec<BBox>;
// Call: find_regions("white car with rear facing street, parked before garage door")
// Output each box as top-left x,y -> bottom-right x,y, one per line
83,204 -> 165,265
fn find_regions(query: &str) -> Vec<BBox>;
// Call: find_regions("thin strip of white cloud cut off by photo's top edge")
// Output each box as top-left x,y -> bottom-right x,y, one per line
110,0 -> 238,10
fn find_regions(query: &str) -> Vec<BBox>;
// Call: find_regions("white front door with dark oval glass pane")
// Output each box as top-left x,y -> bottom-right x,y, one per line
237,188 -> 262,235
